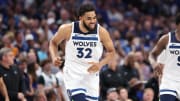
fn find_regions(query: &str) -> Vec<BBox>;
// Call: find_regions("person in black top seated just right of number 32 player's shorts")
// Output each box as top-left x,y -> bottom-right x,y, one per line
100,54 -> 128,100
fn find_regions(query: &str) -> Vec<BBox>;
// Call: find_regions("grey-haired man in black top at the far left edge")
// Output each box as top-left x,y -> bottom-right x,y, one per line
0,48 -> 26,101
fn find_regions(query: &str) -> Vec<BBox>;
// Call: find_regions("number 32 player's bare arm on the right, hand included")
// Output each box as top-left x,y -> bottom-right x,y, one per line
88,27 -> 115,73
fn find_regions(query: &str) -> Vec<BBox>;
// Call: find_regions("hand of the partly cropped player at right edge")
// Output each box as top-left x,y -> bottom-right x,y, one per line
154,63 -> 164,77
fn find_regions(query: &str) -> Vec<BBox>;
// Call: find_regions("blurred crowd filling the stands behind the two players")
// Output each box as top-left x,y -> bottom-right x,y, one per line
0,0 -> 180,101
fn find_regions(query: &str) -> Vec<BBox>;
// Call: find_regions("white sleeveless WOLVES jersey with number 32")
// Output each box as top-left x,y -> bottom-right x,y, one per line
65,22 -> 103,73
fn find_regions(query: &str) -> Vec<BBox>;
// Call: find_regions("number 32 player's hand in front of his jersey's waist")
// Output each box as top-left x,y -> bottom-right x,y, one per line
88,62 -> 101,73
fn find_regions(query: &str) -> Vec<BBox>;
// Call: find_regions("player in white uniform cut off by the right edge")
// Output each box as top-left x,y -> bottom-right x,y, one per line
149,14 -> 180,101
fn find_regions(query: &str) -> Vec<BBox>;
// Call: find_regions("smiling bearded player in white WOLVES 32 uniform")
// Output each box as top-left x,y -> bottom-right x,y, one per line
49,4 -> 115,101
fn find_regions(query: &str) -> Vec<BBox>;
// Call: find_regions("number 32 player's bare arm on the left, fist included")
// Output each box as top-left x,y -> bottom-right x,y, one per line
49,24 -> 72,66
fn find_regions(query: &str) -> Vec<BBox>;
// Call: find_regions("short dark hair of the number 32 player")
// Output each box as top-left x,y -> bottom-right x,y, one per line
78,3 -> 95,17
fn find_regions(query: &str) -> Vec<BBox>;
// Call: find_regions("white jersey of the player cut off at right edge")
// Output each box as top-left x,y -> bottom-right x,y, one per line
163,32 -> 180,81
